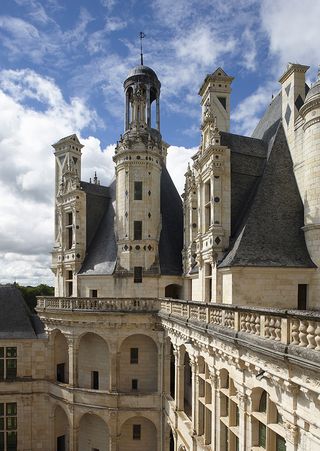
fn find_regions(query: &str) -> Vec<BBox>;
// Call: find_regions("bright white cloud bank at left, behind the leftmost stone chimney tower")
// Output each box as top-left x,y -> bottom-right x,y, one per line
0,70 -> 105,283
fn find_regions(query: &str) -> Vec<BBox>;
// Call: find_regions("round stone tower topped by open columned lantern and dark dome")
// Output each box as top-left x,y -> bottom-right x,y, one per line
114,65 -> 167,281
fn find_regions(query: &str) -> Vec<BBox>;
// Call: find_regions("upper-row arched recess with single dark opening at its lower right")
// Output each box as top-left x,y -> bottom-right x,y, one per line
78,333 -> 109,390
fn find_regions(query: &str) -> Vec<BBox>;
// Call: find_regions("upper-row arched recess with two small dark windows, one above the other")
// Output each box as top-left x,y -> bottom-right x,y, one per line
118,334 -> 158,393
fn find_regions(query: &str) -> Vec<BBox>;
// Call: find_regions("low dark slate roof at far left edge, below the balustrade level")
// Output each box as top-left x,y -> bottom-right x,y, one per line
0,286 -> 45,339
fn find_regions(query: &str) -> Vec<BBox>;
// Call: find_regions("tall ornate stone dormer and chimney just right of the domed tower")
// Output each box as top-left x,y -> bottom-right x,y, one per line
183,68 -> 233,301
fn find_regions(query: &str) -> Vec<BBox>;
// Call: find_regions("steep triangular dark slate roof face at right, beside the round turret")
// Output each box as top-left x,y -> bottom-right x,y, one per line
219,123 -> 315,268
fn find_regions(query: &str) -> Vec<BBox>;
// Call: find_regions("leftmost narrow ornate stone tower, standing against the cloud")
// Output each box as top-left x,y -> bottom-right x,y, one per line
51,135 -> 86,296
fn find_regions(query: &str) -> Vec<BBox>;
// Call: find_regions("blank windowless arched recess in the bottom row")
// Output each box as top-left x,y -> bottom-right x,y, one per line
79,413 -> 109,451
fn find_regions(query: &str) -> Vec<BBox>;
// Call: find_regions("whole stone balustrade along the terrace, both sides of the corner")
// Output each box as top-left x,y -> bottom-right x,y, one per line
37,296 -> 320,351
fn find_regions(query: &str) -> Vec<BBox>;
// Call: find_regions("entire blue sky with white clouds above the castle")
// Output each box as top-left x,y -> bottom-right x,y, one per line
0,0 -> 320,284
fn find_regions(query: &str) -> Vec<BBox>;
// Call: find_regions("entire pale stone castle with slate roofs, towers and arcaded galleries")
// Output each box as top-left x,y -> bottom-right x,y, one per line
0,64 -> 320,451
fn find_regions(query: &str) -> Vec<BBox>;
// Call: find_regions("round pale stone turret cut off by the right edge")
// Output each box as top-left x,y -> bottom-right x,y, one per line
300,71 -> 320,266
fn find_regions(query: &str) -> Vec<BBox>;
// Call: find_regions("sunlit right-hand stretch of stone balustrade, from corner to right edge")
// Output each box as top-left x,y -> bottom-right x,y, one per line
160,299 -> 320,351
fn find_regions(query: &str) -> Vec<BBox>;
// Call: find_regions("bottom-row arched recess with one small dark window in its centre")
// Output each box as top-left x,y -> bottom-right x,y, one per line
119,417 -> 157,451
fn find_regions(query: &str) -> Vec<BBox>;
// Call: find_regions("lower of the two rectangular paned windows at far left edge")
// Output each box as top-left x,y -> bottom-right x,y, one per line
0,402 -> 17,451
